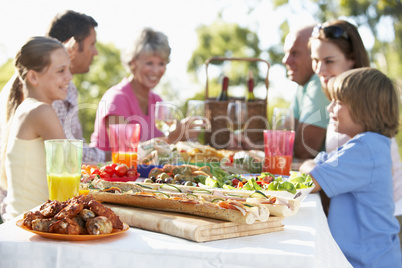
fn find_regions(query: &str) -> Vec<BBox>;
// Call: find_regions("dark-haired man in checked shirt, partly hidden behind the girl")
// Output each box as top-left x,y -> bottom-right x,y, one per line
46,10 -> 106,163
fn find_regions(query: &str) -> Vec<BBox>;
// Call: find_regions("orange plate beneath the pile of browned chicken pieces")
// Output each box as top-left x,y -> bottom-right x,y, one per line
16,219 -> 130,241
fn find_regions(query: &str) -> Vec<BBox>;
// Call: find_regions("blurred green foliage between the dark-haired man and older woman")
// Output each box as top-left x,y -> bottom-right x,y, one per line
73,42 -> 127,142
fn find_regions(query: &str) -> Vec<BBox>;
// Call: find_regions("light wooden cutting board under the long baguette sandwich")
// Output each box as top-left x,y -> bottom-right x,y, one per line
103,203 -> 284,242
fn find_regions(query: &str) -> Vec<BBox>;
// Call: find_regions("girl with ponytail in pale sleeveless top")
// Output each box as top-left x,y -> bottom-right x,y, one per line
0,37 -> 72,220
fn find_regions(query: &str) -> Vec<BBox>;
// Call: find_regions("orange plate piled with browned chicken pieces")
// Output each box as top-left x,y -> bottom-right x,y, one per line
16,195 -> 129,241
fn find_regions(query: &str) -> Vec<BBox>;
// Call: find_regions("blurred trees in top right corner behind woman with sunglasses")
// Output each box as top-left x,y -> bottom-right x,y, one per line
270,0 -> 402,155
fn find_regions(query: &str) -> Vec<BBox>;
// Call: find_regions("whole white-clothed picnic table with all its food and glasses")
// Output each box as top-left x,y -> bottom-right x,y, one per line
0,66 -> 351,267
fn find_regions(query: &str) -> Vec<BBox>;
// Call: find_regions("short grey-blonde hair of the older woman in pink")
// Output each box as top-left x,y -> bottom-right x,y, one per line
122,28 -> 171,71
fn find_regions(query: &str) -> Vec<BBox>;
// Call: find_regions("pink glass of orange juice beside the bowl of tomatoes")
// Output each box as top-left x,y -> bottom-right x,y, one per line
109,124 -> 141,169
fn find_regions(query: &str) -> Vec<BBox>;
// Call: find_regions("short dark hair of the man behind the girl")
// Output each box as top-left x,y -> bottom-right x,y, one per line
46,10 -> 98,47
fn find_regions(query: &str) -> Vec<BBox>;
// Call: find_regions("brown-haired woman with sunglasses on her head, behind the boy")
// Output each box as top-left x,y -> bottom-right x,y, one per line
309,20 -> 402,216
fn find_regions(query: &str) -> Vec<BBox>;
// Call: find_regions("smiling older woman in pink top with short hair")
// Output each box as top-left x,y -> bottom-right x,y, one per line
91,28 -> 171,151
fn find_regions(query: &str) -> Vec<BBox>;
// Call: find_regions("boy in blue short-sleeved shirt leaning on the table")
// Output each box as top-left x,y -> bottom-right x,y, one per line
300,68 -> 402,267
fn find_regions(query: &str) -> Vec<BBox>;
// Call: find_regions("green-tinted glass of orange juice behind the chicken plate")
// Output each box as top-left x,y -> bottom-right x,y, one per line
45,139 -> 83,202
